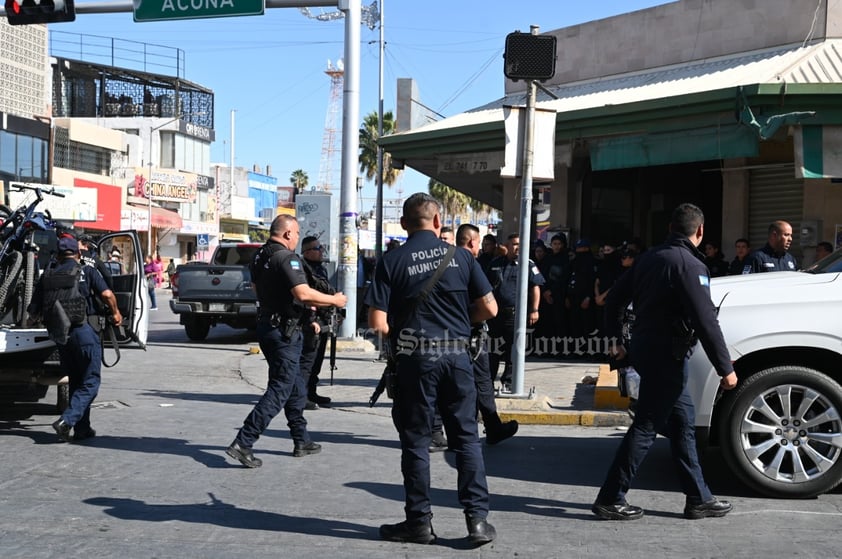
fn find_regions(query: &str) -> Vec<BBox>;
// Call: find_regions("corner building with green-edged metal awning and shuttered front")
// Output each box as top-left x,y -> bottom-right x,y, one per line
382,0 -> 842,264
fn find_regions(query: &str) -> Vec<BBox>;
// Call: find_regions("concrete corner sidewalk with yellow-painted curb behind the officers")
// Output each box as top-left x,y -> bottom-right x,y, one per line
240,342 -> 631,427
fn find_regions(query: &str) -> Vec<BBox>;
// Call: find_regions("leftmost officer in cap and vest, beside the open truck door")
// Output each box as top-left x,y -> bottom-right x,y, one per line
29,234 -> 123,441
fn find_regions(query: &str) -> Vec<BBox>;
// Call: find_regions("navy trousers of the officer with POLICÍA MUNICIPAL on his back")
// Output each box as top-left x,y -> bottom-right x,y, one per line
392,350 -> 488,521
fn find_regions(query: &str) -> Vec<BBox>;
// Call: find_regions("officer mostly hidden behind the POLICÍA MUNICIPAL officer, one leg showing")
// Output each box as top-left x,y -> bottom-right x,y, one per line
456,223 -> 518,444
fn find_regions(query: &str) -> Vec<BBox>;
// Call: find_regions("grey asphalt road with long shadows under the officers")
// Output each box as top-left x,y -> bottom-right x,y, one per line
0,297 -> 842,559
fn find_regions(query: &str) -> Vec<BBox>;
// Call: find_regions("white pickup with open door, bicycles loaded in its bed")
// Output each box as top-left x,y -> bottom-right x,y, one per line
0,231 -> 149,410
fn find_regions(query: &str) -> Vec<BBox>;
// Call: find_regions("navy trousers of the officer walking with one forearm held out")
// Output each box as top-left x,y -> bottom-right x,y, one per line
234,321 -> 311,448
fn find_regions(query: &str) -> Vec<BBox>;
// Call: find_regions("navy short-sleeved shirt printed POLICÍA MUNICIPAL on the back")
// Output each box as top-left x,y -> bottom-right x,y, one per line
366,230 -> 491,340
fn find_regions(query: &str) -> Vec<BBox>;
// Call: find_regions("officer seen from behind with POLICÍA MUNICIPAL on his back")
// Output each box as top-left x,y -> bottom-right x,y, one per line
367,193 -> 497,545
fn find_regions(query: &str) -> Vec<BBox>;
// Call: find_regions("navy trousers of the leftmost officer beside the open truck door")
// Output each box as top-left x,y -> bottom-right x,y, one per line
58,323 -> 102,434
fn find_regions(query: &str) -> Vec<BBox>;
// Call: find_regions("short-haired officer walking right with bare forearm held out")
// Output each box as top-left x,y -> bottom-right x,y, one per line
226,215 -> 347,468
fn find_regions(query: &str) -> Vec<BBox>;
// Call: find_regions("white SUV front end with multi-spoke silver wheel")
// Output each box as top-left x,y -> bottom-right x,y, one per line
688,251 -> 842,497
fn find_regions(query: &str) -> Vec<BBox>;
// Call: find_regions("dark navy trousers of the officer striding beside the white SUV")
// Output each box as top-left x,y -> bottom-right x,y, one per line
597,340 -> 713,504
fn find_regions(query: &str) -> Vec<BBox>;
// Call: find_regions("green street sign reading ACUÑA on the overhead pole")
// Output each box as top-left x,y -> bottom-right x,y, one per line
134,0 -> 264,21
